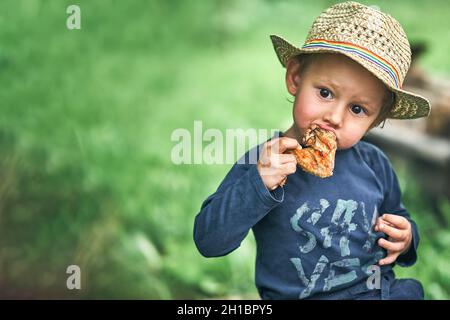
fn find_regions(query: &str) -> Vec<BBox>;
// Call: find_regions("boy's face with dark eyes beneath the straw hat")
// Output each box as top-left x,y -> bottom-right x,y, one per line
286,53 -> 387,149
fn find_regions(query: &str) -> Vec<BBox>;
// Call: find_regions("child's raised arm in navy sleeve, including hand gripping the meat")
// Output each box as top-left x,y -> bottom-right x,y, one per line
194,137 -> 298,257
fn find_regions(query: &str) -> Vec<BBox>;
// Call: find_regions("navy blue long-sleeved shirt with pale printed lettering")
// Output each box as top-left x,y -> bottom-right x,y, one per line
194,133 -> 419,299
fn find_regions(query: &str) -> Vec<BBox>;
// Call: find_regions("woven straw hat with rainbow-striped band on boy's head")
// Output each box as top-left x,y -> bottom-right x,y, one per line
270,1 -> 430,119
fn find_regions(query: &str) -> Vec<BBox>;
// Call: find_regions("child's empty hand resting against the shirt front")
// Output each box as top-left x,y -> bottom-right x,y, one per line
375,214 -> 412,266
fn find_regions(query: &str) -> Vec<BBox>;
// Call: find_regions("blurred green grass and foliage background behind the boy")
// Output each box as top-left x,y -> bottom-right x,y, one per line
0,0 -> 450,299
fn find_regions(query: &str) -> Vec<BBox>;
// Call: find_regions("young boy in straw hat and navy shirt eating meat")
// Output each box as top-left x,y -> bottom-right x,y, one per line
194,2 -> 430,299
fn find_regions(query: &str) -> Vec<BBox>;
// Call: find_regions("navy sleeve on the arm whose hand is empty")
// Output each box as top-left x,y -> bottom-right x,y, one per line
379,146 -> 420,267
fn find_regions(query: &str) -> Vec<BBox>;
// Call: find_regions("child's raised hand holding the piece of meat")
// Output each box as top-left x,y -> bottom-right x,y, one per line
256,137 -> 301,190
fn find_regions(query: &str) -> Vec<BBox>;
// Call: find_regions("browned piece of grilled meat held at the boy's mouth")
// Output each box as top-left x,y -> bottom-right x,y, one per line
289,125 -> 337,178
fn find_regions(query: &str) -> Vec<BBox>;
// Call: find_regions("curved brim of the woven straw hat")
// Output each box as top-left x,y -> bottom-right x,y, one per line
270,35 -> 431,119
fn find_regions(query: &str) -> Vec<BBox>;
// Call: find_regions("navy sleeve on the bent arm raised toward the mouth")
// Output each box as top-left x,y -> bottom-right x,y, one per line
194,145 -> 284,257
